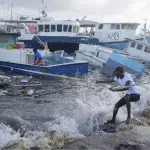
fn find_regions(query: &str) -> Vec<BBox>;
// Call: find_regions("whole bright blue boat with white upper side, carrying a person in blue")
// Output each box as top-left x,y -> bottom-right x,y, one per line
0,49 -> 88,80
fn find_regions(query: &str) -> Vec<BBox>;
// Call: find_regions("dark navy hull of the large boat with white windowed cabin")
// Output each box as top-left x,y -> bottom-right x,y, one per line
19,36 -> 99,53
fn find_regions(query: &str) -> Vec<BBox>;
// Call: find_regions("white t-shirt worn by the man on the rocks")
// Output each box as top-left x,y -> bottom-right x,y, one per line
114,73 -> 140,94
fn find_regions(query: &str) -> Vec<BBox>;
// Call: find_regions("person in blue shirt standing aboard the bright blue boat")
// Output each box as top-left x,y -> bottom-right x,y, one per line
33,48 -> 44,66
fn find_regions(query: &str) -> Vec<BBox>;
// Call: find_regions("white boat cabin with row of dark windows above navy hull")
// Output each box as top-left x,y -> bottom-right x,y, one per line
37,20 -> 80,36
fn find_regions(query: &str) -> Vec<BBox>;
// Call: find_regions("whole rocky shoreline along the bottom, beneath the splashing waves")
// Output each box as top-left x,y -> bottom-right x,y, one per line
2,115 -> 150,150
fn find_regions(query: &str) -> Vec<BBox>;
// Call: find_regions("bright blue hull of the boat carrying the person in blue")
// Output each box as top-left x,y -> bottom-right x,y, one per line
0,61 -> 88,80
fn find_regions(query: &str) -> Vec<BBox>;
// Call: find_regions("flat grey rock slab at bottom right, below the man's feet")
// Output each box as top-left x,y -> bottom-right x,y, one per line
63,126 -> 150,150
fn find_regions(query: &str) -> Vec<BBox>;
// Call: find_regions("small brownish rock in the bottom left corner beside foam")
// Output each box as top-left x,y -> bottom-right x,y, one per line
2,141 -> 29,150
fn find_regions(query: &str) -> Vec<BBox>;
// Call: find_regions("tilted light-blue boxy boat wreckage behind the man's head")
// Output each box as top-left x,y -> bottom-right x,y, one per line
101,53 -> 144,76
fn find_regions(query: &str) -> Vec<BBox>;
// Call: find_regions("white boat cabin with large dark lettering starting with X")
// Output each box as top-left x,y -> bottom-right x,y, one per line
94,23 -> 139,43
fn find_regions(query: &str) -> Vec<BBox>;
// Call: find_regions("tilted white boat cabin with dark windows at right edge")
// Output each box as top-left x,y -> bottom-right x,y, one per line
124,39 -> 150,62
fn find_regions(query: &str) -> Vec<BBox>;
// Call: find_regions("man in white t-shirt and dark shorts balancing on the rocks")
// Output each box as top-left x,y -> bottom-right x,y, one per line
96,66 -> 140,124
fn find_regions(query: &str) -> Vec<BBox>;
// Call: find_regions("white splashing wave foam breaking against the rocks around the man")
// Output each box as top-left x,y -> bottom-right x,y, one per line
0,71 -> 150,148
